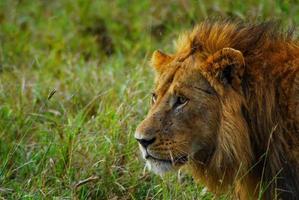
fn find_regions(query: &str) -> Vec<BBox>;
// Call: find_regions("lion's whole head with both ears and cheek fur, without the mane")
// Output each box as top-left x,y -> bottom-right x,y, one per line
135,48 -> 250,174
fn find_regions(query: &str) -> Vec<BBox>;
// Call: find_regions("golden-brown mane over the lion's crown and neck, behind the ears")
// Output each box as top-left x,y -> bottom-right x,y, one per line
174,21 -> 299,199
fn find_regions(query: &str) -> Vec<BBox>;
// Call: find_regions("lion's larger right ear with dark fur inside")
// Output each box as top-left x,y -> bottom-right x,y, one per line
207,48 -> 245,89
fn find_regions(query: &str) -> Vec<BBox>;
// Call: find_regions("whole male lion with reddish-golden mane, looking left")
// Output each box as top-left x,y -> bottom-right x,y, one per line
135,21 -> 299,199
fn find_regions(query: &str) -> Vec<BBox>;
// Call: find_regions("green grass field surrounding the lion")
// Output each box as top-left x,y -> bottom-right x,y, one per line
0,0 -> 299,200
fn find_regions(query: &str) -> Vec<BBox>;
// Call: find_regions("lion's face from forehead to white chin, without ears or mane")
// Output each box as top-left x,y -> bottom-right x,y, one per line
135,55 -> 220,174
